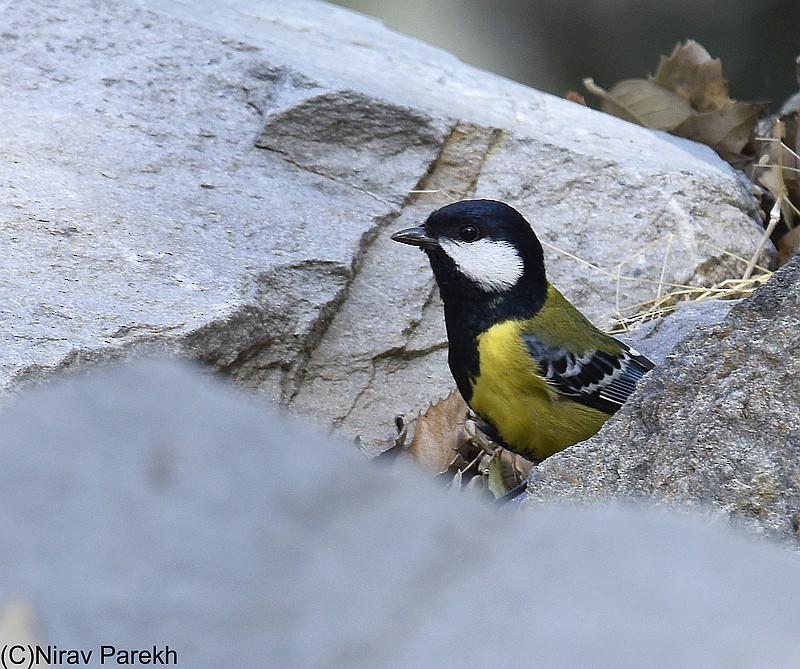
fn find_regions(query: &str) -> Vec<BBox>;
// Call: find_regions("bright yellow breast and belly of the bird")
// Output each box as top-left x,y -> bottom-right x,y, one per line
469,320 -> 608,460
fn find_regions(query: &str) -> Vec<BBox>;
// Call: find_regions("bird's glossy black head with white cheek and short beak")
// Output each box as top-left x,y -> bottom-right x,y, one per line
392,200 -> 547,321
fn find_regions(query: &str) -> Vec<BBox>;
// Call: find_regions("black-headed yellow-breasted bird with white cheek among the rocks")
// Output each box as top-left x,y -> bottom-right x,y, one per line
391,200 -> 654,462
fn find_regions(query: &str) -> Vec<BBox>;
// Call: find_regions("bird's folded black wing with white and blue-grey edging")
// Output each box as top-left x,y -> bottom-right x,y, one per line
522,333 -> 653,414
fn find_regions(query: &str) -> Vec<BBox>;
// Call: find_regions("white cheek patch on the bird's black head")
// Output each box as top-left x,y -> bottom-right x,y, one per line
439,237 -> 523,292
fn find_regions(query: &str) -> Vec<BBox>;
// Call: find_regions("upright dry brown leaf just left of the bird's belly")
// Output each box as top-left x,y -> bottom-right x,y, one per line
408,390 -> 468,474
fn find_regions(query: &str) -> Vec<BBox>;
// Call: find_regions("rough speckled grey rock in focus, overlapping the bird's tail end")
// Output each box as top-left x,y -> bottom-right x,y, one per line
528,257 -> 800,543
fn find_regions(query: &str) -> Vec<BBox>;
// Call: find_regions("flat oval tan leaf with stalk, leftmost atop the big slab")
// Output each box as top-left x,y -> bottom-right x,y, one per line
583,79 -> 695,130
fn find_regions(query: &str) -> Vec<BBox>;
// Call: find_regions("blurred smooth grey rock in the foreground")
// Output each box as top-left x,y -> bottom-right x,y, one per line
0,362 -> 800,669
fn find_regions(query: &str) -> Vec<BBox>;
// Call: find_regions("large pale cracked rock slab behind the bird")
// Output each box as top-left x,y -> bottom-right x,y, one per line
0,0 -> 772,452
